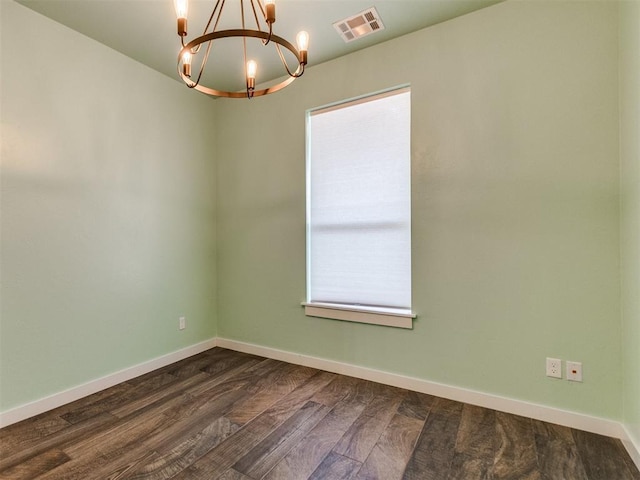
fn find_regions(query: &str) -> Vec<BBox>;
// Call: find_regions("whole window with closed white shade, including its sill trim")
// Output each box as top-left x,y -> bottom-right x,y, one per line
305,87 -> 414,328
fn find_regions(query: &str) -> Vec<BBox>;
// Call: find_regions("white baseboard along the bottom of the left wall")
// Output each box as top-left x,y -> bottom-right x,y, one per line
0,338 -> 217,428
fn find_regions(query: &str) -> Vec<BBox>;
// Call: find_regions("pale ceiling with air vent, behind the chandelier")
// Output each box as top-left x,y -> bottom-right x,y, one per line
17,0 -> 502,94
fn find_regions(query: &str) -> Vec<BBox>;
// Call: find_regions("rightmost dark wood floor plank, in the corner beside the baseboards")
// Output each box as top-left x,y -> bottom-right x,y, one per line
572,430 -> 633,480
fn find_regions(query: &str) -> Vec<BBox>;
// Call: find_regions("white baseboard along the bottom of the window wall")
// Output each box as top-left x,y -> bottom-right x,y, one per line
217,338 -> 628,441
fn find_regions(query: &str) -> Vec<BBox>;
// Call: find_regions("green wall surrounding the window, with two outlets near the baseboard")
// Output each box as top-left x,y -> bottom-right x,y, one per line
216,1 -> 622,419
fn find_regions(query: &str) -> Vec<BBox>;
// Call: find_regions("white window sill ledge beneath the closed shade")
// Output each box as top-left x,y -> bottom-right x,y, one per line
302,303 -> 416,329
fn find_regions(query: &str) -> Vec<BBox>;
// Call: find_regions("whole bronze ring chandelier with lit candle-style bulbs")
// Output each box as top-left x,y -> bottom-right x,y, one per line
174,0 -> 309,98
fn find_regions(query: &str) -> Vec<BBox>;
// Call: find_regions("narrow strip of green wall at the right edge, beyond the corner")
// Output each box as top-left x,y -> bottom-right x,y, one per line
620,1 -> 640,448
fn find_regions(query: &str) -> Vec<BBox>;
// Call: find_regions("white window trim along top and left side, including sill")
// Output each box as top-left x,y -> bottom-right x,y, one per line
301,84 -> 417,329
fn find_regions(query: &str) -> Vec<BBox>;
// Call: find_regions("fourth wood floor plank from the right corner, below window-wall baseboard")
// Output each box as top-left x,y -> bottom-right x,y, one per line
447,404 -> 497,480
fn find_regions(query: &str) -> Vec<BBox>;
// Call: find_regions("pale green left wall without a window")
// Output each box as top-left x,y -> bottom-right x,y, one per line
0,0 -> 216,411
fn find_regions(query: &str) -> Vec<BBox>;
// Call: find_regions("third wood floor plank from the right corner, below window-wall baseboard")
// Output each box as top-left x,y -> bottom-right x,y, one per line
490,412 -> 542,480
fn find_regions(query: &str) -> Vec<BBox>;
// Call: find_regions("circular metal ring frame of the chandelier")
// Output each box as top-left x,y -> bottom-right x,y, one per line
178,29 -> 304,98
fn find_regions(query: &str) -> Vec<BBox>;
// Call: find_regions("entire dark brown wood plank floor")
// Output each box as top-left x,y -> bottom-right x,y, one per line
0,348 -> 640,480
